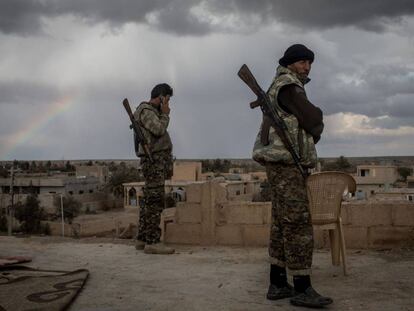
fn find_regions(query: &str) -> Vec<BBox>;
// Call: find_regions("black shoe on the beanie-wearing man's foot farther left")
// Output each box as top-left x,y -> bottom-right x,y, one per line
266,265 -> 294,300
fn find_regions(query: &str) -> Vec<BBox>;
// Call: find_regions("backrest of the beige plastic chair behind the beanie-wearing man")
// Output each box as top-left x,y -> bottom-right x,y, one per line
307,172 -> 356,224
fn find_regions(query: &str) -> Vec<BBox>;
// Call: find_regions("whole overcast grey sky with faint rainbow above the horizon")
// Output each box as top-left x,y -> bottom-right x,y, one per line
0,0 -> 414,160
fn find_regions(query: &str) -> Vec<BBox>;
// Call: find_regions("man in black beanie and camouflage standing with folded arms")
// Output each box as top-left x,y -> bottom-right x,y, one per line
253,44 -> 332,307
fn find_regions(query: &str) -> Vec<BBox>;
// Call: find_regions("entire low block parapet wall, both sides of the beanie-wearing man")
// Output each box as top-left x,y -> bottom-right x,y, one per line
165,182 -> 414,248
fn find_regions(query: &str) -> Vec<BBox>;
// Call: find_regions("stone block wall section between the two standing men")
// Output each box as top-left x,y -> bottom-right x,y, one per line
165,181 -> 270,246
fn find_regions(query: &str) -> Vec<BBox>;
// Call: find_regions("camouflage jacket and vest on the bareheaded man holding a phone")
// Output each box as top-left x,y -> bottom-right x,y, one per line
134,102 -> 172,157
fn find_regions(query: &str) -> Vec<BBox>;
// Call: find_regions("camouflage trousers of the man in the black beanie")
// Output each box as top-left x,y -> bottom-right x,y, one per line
266,163 -> 313,275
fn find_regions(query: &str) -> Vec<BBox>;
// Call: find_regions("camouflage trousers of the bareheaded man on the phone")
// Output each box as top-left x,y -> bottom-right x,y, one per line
137,151 -> 172,244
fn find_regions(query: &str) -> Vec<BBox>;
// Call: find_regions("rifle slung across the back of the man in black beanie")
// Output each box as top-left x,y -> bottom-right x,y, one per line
237,64 -> 308,179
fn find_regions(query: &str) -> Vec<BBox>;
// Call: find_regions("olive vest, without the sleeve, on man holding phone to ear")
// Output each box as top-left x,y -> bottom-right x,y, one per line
134,102 -> 172,157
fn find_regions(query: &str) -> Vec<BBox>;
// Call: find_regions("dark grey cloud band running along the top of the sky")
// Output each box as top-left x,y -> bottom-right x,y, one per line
0,0 -> 414,35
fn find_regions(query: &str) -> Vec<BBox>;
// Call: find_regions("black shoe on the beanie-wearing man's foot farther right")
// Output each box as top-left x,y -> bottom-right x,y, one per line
290,275 -> 333,308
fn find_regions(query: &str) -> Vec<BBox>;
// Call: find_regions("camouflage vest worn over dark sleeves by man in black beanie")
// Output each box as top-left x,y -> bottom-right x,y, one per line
253,66 -> 317,168
